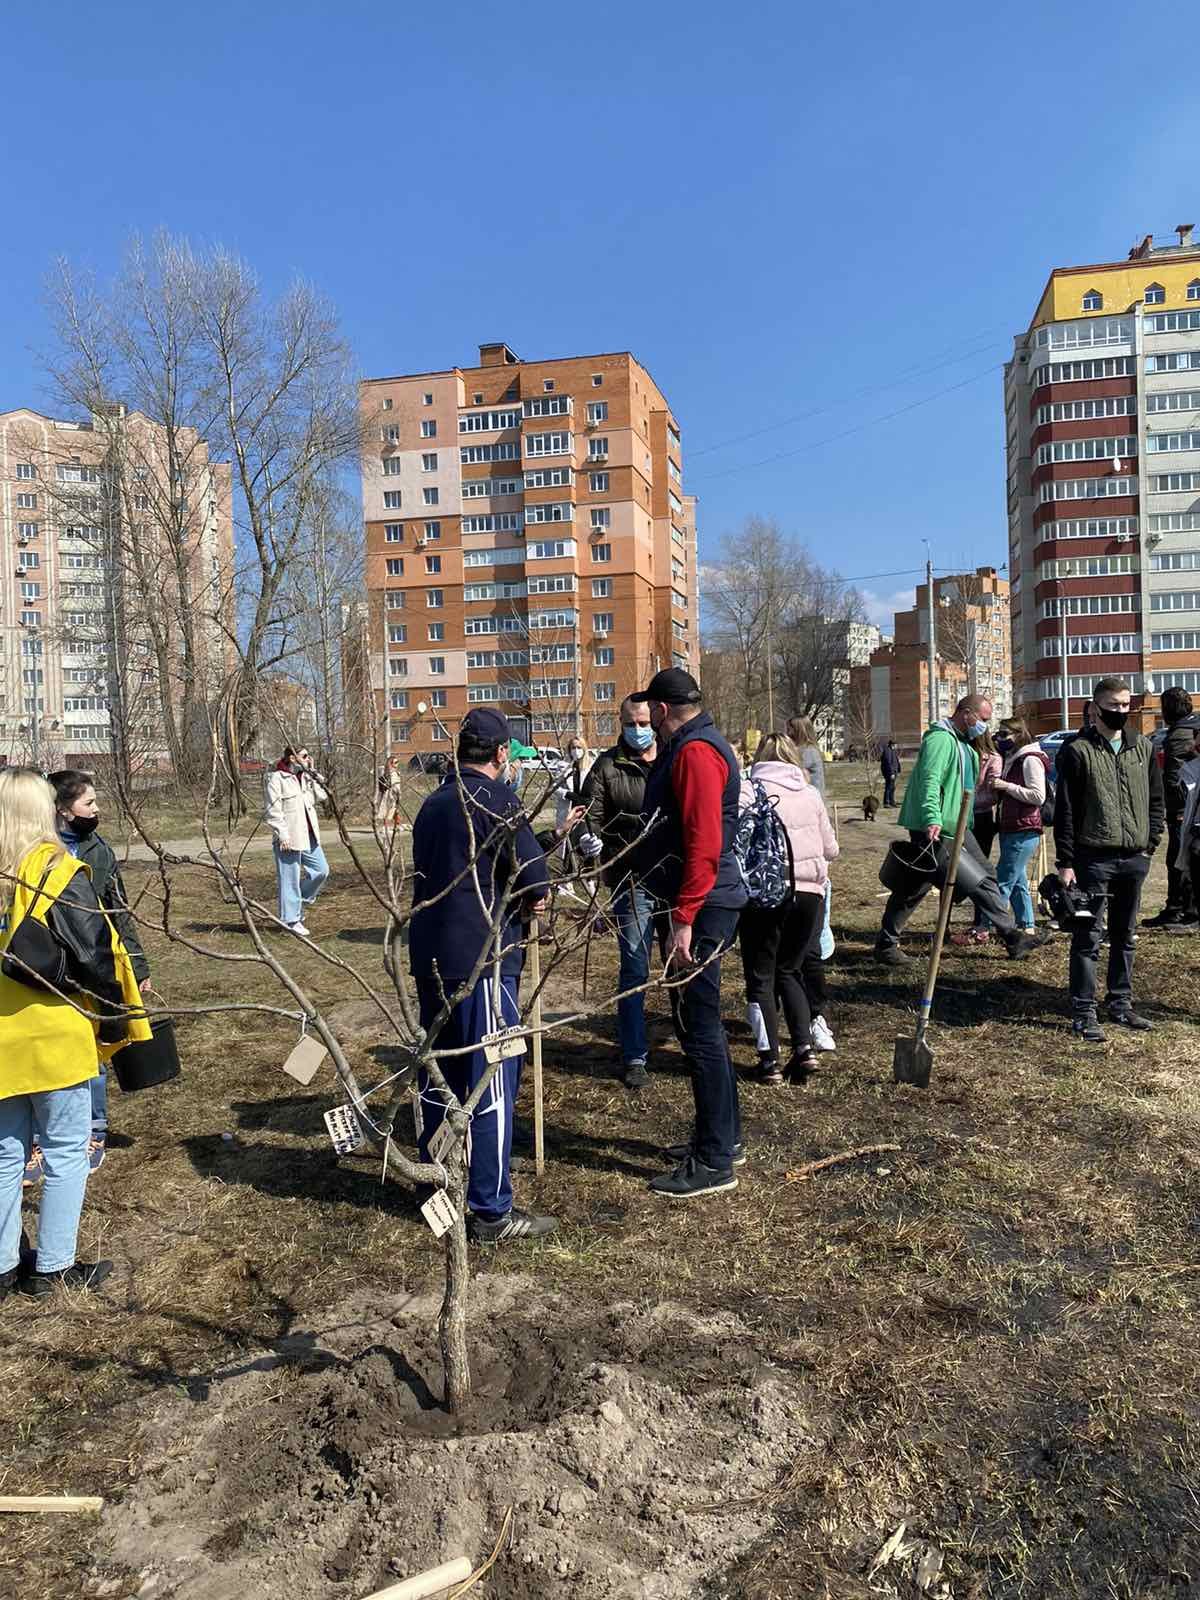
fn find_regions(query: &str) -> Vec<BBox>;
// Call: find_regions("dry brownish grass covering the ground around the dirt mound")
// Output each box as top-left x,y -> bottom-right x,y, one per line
0,773 -> 1200,1600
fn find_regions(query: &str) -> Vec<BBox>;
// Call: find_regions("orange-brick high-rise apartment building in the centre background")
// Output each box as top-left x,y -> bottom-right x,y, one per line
362,344 -> 699,754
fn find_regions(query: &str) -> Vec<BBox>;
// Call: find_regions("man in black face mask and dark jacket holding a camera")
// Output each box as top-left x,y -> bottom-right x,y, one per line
1054,677 -> 1166,1045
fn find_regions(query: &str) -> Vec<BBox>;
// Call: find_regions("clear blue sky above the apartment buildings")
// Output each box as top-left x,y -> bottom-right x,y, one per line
0,0 -> 1200,624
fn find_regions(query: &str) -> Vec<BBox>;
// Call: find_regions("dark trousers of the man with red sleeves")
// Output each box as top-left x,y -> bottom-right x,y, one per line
656,906 -> 742,1173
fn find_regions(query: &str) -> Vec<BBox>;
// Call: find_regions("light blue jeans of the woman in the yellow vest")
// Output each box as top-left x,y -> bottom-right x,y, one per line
0,1082 -> 91,1272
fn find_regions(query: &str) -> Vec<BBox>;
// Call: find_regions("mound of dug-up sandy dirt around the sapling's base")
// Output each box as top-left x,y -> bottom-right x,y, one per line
106,1277 -> 811,1600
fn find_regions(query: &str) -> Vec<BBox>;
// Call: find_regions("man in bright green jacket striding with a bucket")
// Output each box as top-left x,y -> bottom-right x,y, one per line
875,694 -> 1043,966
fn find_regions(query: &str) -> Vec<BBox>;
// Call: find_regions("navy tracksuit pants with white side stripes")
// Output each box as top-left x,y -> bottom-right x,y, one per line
416,973 -> 525,1222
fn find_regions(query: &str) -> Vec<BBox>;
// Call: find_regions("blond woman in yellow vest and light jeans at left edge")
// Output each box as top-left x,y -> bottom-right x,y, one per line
0,766 -> 150,1299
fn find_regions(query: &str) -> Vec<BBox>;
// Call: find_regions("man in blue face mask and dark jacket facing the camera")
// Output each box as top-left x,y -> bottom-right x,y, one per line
579,699 -> 658,1090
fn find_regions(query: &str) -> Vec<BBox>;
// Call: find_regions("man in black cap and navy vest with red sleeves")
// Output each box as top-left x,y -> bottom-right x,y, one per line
629,667 -> 746,1200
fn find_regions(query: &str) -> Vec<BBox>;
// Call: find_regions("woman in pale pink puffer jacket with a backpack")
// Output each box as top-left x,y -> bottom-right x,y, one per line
741,733 -> 838,1083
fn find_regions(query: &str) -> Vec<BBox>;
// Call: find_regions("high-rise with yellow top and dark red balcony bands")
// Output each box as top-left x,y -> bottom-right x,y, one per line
1005,226 -> 1200,731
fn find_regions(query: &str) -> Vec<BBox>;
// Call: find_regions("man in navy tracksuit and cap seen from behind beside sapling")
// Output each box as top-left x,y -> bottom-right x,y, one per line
408,707 -> 557,1243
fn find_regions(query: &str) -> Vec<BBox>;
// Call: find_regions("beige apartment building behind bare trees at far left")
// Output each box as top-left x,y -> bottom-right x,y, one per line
0,405 -> 234,765
